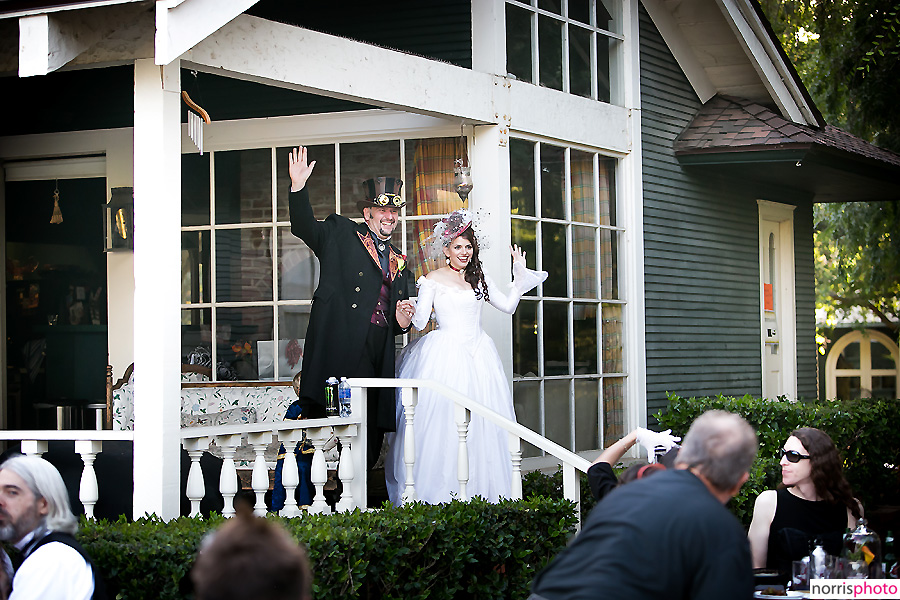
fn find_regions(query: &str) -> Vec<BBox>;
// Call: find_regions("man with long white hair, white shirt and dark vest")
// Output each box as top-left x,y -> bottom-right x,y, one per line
0,456 -> 105,600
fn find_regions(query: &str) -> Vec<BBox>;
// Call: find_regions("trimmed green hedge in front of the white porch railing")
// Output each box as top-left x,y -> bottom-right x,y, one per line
78,498 -> 575,600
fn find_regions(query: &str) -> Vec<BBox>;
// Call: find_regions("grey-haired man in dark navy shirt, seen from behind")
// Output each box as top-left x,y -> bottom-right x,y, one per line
530,411 -> 757,600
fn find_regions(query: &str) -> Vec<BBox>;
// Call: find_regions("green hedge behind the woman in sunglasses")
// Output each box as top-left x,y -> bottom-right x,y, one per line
656,394 -> 900,524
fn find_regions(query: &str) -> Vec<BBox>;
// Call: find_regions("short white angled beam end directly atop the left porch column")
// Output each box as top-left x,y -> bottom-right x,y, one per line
155,0 -> 258,65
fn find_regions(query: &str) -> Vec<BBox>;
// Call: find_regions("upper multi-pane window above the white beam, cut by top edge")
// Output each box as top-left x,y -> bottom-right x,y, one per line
506,0 -> 624,102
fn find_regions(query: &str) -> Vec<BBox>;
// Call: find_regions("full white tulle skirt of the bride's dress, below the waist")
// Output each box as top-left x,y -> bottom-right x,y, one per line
385,329 -> 516,504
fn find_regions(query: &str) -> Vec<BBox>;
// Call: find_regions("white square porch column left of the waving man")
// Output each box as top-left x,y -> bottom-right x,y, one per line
134,59 -> 181,519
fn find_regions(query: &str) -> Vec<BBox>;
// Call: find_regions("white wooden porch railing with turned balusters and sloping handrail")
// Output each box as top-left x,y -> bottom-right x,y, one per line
0,378 -> 590,517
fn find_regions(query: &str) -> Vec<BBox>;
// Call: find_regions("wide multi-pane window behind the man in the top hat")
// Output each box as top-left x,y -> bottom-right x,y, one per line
181,138 -> 462,381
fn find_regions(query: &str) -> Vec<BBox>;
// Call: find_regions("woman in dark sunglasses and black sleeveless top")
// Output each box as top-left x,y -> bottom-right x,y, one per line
748,427 -> 862,576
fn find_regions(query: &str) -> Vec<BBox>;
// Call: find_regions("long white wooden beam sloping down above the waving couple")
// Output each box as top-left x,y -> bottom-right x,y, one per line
182,15 -> 630,153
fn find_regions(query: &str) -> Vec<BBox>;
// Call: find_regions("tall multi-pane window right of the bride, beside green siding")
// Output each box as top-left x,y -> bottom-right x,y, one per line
509,139 -> 626,455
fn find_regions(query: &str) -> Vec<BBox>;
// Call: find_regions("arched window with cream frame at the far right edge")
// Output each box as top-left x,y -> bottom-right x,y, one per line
825,330 -> 900,400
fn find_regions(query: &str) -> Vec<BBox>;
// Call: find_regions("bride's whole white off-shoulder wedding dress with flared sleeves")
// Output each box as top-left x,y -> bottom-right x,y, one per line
385,263 -> 547,505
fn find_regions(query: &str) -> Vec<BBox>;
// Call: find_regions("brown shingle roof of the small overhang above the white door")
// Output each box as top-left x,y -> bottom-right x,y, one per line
675,95 -> 900,167
